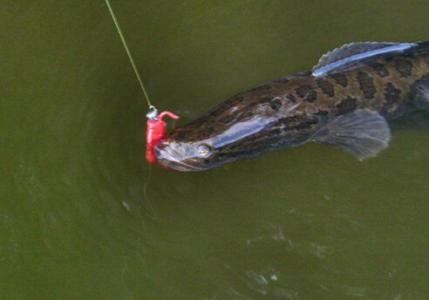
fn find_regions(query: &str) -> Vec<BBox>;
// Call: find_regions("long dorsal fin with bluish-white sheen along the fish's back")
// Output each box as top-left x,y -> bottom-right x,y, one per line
312,42 -> 417,77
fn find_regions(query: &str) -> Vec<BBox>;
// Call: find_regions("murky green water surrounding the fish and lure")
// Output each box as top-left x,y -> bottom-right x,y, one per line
0,0 -> 429,300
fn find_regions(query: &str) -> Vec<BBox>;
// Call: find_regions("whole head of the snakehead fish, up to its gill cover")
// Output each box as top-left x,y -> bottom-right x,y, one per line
155,75 -> 307,171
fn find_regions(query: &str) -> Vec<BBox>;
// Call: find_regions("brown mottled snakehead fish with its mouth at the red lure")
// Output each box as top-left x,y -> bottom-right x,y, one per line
155,41 -> 429,171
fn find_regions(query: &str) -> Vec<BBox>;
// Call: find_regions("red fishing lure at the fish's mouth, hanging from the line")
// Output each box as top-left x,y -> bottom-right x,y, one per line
146,106 -> 179,164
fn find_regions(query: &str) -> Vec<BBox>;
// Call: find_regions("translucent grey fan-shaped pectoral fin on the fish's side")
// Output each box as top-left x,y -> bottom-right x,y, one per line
313,109 -> 390,160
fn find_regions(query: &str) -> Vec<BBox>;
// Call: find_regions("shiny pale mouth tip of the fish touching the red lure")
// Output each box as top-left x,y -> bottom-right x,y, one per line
155,141 -> 205,172
